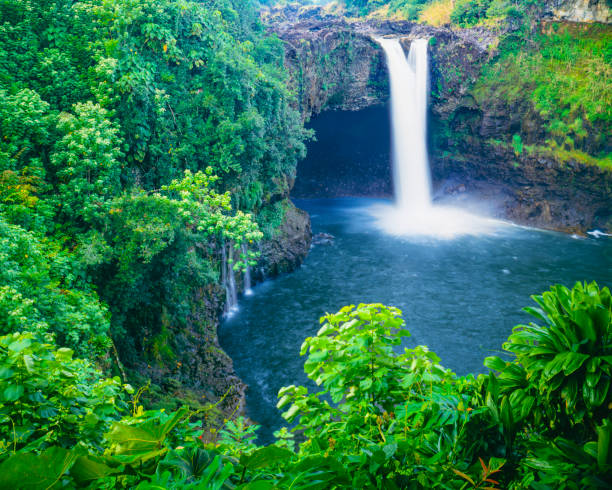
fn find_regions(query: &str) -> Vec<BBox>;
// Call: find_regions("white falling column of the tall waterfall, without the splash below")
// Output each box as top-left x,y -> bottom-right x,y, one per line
379,39 -> 431,214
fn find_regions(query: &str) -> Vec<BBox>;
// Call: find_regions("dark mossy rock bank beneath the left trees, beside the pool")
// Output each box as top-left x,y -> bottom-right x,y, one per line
125,200 -> 312,418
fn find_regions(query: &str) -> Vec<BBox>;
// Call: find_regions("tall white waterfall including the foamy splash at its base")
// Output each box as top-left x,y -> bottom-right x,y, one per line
372,38 -> 492,238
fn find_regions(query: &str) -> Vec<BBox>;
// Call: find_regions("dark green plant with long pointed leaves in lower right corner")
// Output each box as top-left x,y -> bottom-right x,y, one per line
485,283 -> 612,488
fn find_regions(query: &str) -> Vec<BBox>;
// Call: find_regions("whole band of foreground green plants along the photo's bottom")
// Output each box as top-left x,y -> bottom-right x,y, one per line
0,283 -> 612,489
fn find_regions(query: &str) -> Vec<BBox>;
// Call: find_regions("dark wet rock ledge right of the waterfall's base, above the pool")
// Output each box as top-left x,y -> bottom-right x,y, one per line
432,148 -> 612,233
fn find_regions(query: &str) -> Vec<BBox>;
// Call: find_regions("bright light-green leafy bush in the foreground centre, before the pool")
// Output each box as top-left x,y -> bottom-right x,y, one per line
278,304 -> 484,488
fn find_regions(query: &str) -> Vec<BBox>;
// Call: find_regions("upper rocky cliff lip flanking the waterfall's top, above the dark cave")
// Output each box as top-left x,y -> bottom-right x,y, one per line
270,7 -> 497,118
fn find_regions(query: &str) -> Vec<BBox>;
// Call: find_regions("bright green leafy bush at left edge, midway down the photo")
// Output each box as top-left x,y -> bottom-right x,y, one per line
0,216 -> 109,357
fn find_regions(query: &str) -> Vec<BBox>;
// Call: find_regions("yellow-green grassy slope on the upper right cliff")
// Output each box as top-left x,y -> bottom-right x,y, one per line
473,23 -> 612,161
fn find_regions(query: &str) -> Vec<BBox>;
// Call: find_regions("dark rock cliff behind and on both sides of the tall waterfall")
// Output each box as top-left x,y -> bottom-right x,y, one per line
271,7 -> 612,232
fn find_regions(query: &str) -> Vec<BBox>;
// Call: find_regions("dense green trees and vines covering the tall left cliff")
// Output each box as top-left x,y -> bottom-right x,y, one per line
0,0 -> 308,376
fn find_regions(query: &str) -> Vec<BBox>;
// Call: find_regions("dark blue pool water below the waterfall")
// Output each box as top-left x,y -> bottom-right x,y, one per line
219,198 -> 612,442
